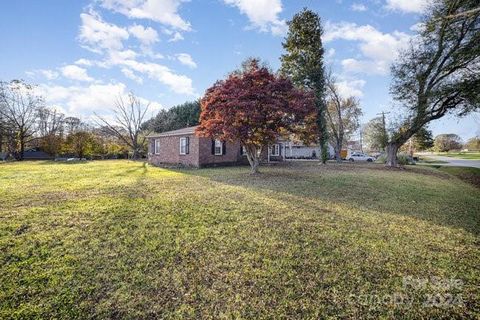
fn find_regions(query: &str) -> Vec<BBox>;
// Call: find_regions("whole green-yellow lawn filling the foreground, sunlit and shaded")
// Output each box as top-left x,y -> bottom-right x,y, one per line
0,161 -> 480,319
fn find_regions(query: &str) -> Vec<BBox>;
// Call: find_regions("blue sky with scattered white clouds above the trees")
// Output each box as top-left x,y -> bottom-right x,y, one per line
0,0 -> 480,139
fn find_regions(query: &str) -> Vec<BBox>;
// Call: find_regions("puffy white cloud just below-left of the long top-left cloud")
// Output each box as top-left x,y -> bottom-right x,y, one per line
79,10 -> 129,52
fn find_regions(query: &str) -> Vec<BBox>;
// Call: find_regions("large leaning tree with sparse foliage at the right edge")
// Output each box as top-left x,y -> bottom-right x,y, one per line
387,0 -> 480,166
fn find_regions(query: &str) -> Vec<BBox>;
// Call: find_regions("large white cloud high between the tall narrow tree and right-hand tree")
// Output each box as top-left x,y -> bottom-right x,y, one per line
323,22 -> 410,75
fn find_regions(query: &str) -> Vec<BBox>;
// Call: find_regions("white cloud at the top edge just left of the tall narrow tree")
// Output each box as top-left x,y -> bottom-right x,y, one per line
224,0 -> 287,35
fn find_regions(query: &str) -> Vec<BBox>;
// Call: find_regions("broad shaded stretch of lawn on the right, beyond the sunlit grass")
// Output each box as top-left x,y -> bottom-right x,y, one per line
172,163 -> 480,235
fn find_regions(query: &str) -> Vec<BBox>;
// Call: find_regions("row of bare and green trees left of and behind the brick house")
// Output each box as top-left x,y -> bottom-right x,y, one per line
0,80 -> 200,160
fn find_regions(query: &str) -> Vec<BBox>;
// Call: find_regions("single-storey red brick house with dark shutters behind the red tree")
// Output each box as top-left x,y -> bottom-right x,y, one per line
147,126 -> 284,168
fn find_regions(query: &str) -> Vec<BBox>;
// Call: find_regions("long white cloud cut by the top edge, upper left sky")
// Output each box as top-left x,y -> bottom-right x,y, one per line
101,0 -> 191,31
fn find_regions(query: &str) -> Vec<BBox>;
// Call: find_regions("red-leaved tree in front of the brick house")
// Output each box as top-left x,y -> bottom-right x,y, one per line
197,59 -> 316,173
